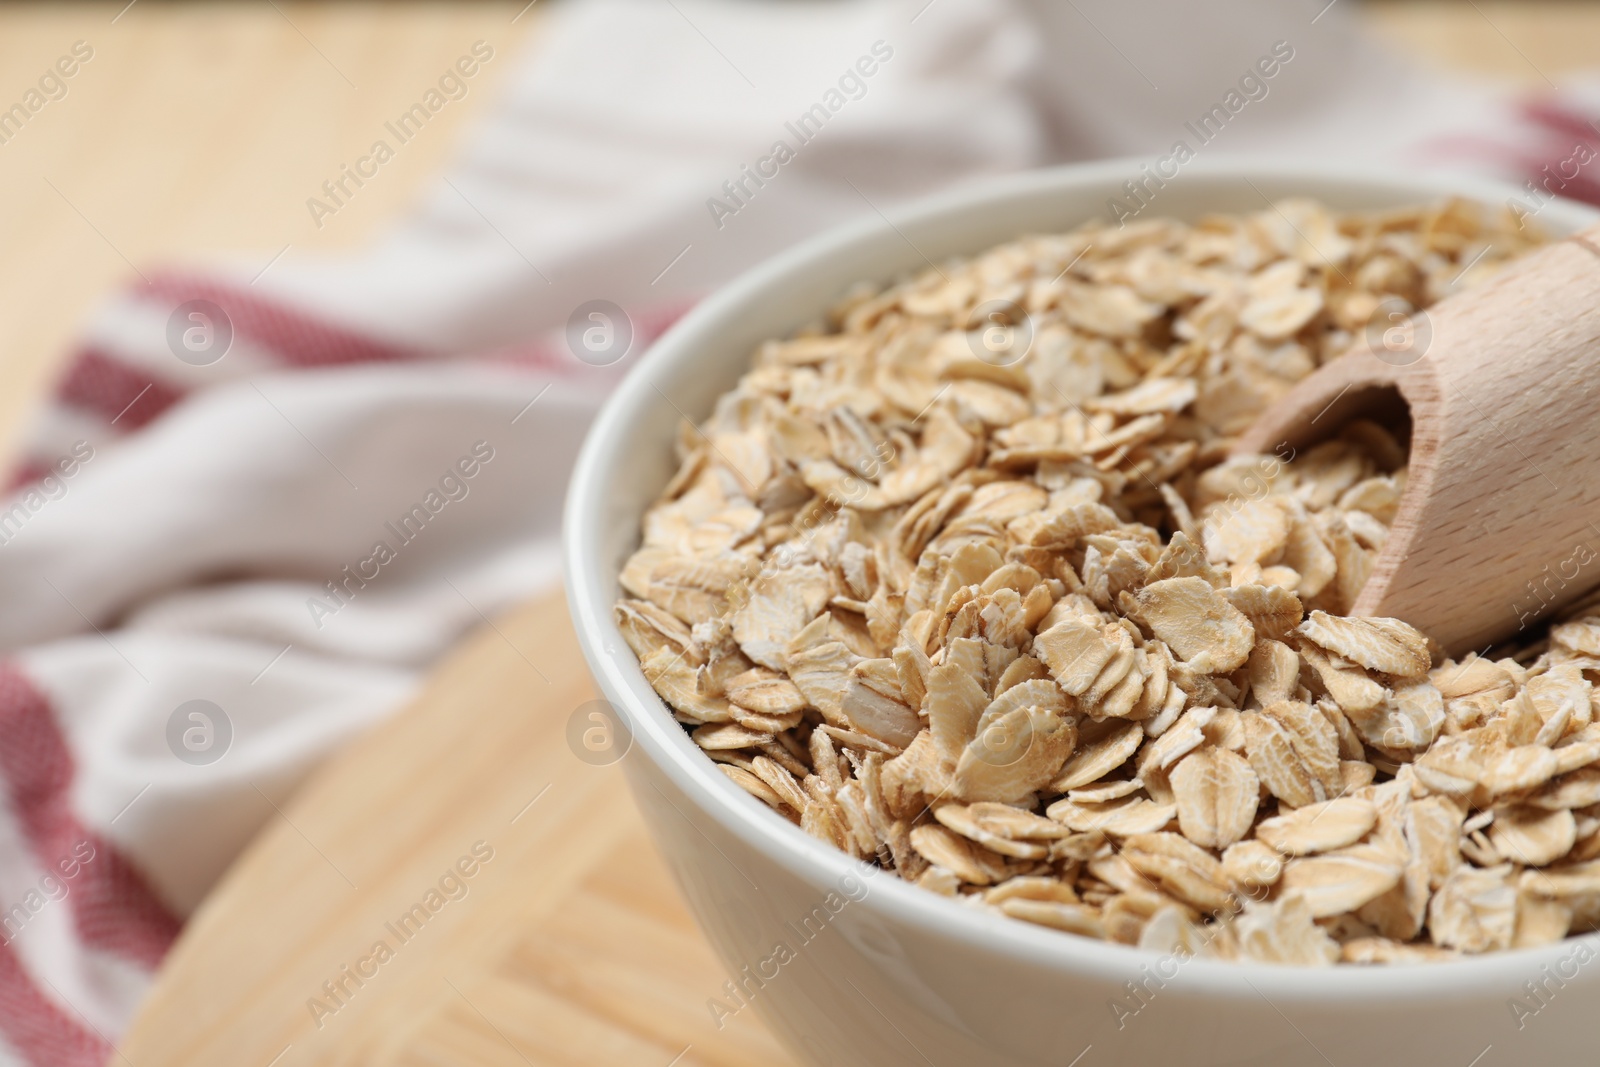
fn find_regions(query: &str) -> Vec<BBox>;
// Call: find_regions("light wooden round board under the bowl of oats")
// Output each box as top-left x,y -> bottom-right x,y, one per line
118,593 -> 792,1067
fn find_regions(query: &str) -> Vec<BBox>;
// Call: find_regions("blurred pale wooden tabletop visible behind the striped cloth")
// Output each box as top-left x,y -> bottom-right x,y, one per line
0,0 -> 1600,451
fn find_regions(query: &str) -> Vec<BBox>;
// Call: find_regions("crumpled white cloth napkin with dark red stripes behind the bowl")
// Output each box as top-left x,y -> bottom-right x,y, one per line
0,0 -> 1597,1067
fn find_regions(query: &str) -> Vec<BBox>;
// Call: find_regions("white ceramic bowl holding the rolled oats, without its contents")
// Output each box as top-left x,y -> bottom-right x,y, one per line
565,160 -> 1600,1067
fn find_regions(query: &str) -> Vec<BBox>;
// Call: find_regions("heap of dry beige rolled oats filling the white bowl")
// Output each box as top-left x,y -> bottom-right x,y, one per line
616,200 -> 1600,965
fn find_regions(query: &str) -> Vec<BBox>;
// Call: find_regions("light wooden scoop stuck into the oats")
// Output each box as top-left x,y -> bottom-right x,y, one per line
1234,226 -> 1600,656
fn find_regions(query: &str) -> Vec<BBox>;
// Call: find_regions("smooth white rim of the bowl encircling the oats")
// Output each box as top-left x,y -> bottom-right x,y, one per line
562,157 -> 1600,1008
